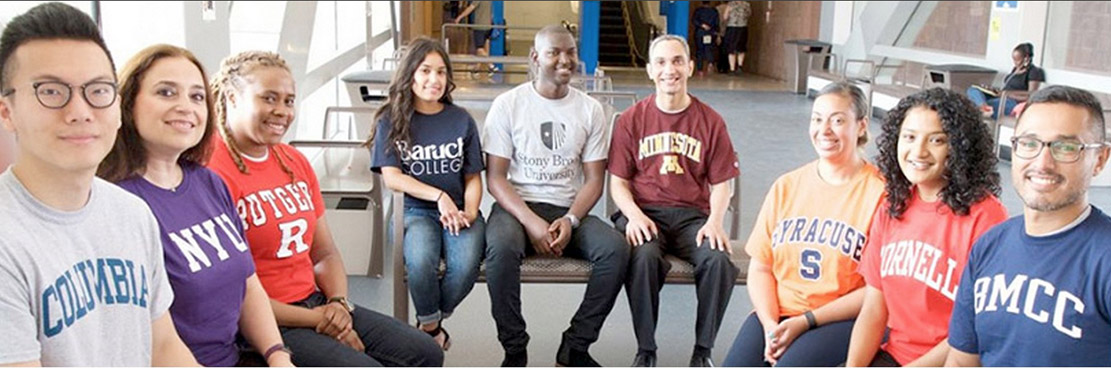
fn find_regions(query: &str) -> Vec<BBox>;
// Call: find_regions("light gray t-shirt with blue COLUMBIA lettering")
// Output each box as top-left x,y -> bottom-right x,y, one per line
0,170 -> 173,367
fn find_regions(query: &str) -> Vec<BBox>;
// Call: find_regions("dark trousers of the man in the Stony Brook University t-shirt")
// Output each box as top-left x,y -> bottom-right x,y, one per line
486,202 -> 629,354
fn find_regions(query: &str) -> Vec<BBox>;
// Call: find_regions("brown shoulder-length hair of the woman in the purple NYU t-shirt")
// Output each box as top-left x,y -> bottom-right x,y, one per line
97,44 -> 214,182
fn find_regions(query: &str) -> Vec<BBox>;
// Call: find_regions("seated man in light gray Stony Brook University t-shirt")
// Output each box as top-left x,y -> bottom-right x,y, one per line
483,26 -> 629,367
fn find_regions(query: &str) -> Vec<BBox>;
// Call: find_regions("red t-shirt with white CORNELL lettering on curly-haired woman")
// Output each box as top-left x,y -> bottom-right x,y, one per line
860,190 -> 1007,366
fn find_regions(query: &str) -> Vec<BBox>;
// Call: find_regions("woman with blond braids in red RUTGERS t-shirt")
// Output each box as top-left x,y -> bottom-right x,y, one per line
209,51 -> 443,367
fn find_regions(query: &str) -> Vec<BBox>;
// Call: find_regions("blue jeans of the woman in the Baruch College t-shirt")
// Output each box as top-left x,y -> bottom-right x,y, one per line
404,208 -> 486,324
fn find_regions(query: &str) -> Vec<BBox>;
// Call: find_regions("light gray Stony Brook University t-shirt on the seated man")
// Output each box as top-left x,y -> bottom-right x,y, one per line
482,82 -> 610,207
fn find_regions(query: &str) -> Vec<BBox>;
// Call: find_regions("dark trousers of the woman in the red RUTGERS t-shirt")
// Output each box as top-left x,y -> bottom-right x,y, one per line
280,291 -> 443,367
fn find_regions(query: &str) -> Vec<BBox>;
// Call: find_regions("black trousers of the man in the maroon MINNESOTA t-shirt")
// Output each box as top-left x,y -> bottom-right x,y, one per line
613,207 -> 744,352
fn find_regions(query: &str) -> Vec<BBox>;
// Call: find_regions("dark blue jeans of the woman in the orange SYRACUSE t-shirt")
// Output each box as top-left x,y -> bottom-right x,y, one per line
721,311 -> 857,367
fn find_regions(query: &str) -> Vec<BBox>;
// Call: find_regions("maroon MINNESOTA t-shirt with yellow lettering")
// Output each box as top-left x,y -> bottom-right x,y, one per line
608,95 -> 741,213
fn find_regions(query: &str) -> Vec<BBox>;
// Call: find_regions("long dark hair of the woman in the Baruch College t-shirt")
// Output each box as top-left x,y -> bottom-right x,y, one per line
367,37 -> 456,149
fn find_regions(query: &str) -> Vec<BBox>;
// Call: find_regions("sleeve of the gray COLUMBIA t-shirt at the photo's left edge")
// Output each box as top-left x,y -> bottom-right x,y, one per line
0,241 -> 42,365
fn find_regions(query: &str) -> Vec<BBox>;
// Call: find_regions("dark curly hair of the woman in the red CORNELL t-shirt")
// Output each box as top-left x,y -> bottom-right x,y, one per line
875,88 -> 1000,219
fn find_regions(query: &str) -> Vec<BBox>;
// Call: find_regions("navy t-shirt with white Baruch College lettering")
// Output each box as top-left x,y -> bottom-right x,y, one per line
370,103 -> 484,209
